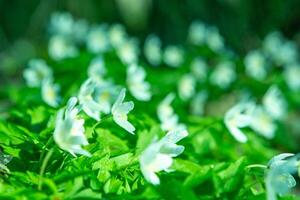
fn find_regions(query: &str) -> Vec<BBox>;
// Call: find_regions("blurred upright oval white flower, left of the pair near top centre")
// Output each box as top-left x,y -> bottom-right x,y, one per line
144,35 -> 162,66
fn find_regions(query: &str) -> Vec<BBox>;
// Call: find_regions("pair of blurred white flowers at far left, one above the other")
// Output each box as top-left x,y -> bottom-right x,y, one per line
23,59 -> 60,107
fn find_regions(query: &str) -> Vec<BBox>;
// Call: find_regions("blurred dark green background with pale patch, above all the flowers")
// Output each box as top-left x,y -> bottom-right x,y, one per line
0,0 -> 300,80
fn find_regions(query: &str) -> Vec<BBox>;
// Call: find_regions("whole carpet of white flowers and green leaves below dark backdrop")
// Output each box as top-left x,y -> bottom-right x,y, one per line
0,12 -> 300,200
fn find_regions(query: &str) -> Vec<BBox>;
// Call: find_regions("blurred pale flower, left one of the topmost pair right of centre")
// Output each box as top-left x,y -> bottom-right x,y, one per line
188,21 -> 206,45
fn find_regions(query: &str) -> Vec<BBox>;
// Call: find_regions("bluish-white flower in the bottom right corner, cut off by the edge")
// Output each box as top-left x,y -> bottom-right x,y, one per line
265,153 -> 299,200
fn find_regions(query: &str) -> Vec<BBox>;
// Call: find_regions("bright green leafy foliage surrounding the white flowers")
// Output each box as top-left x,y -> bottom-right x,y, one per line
0,6 -> 300,200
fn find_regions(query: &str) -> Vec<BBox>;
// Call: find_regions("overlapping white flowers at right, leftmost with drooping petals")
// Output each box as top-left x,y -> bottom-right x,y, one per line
224,86 -> 287,143
